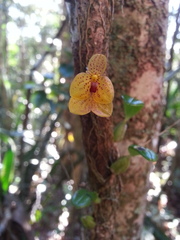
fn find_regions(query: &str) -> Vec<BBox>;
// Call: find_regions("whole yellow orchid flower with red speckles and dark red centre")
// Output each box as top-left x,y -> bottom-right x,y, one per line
69,54 -> 114,117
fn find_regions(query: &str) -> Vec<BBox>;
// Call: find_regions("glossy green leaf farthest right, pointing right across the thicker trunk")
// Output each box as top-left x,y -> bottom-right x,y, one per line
128,145 -> 157,162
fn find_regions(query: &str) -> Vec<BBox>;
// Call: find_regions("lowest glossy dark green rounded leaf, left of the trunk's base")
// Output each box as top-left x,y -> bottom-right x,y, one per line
71,189 -> 99,208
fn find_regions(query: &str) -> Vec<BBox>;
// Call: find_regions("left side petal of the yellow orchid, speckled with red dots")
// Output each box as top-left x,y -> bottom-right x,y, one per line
70,73 -> 91,99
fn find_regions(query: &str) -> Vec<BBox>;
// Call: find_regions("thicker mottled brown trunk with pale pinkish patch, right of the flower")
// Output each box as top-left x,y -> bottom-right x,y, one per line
110,0 -> 168,240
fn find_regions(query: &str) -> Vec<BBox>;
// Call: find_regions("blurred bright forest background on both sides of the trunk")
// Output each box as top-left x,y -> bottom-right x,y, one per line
0,0 -> 180,240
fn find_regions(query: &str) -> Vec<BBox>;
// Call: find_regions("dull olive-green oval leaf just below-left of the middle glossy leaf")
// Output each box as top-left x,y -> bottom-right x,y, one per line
110,156 -> 130,174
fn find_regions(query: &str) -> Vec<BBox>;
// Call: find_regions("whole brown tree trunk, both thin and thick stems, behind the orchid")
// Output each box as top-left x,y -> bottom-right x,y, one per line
67,0 -> 167,240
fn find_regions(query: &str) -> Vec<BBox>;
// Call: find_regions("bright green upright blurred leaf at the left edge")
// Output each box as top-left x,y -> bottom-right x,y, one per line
0,150 -> 14,192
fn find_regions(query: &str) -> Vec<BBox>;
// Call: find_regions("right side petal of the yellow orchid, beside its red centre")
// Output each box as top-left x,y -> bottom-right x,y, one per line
92,76 -> 114,104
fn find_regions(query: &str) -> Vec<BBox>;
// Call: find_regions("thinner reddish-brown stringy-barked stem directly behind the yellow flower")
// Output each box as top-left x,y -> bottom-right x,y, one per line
70,0 -> 120,240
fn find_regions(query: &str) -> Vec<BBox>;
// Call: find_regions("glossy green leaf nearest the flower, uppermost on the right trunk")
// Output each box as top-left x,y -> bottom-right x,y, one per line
122,95 -> 144,121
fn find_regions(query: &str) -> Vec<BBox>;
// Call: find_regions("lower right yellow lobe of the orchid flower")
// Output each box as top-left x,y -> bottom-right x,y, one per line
91,102 -> 113,117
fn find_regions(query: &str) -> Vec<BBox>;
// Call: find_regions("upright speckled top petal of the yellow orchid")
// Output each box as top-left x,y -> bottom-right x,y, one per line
88,54 -> 107,75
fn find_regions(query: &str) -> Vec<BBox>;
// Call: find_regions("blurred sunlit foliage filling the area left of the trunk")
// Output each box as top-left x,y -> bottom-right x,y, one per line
0,0 -> 79,239
